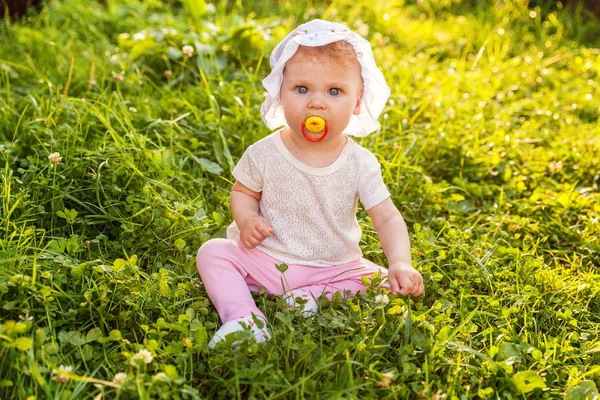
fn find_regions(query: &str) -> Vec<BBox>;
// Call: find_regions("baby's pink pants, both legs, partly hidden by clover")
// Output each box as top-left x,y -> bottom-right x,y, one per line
196,239 -> 389,323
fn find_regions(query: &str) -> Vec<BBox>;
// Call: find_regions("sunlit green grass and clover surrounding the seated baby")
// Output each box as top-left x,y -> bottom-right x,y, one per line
0,0 -> 600,399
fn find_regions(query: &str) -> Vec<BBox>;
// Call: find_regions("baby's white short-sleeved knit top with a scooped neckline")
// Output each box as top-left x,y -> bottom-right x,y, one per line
227,131 -> 390,267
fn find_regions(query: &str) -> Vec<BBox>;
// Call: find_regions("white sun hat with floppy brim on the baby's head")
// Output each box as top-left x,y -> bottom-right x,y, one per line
260,19 -> 390,137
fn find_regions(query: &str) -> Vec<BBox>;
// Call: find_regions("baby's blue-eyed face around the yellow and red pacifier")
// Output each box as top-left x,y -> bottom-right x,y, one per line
280,48 -> 363,140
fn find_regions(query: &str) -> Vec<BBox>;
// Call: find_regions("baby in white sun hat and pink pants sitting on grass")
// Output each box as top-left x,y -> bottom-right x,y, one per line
197,20 -> 424,347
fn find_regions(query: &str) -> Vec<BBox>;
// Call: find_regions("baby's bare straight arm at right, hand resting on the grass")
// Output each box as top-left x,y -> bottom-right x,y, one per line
367,198 -> 425,297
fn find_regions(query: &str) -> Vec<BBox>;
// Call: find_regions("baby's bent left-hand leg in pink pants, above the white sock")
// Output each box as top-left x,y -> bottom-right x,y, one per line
196,239 -> 278,323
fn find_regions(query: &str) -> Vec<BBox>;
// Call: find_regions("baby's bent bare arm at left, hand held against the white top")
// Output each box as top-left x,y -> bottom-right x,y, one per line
230,182 -> 273,249
